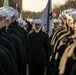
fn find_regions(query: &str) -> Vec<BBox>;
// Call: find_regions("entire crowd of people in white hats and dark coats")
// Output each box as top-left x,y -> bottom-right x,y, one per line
0,6 -> 76,75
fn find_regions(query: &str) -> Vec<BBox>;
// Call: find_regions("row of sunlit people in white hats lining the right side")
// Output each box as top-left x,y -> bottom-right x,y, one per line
49,8 -> 76,75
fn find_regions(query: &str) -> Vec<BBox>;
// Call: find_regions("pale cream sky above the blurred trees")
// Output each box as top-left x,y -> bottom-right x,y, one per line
22,0 -> 66,12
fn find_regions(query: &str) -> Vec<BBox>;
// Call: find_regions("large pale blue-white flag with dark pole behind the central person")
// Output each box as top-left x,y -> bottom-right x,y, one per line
41,0 -> 52,37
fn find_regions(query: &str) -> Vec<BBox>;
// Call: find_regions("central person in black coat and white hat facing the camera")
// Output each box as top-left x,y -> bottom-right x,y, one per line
27,19 -> 51,75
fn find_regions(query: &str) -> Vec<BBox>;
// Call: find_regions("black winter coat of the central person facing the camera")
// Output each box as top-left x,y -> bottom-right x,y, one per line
27,30 -> 51,63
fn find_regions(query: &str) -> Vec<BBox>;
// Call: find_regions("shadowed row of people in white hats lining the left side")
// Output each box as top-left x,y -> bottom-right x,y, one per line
0,6 -> 27,75
